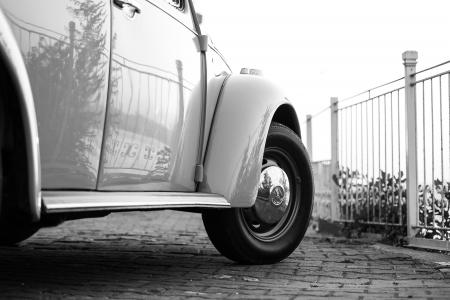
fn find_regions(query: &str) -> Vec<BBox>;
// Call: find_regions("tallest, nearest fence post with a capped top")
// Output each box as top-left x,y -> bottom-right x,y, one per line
402,51 -> 418,238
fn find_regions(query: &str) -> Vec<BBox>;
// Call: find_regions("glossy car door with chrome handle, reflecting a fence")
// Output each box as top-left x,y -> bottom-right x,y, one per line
98,0 -> 201,191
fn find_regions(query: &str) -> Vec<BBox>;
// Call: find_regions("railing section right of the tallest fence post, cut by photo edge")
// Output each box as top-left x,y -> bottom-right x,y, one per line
409,61 -> 450,249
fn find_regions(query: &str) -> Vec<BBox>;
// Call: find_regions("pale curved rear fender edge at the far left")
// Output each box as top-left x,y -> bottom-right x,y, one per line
0,9 -> 41,221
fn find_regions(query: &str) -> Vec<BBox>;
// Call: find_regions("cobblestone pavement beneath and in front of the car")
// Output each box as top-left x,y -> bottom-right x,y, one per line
0,211 -> 450,299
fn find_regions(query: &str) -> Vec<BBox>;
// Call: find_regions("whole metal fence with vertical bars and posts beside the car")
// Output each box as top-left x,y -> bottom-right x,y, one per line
306,51 -> 450,249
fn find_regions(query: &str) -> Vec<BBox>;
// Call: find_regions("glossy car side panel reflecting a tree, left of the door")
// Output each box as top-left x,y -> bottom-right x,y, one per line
0,0 -> 111,190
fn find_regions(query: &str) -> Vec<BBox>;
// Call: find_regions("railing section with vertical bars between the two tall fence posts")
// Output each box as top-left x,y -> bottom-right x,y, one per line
336,83 -> 405,225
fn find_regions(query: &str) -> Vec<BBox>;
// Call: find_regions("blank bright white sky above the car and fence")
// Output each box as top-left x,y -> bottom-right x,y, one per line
194,0 -> 450,159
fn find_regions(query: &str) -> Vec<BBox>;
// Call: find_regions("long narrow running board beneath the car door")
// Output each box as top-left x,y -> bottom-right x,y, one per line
42,191 -> 230,214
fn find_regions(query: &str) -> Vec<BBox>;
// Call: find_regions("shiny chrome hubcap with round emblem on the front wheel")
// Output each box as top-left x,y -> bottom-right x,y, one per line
254,166 -> 290,225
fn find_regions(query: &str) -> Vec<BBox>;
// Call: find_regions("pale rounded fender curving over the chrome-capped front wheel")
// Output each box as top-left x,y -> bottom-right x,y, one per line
199,75 -> 298,207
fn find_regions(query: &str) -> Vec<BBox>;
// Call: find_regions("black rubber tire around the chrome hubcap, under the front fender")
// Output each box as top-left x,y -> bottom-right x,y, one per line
202,123 -> 314,264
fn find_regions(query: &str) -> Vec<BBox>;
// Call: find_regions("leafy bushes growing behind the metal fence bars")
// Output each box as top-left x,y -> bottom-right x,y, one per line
333,168 -> 450,242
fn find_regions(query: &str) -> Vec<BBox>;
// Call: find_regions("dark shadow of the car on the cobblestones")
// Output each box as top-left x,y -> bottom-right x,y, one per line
0,230 -> 300,298
